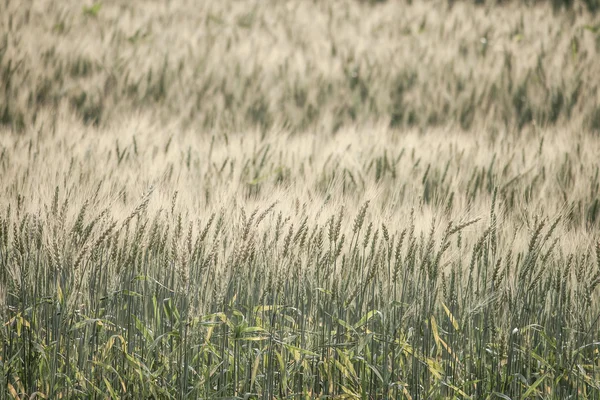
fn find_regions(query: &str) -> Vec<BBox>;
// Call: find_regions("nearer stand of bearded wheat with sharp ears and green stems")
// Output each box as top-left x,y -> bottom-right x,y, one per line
0,121 -> 600,399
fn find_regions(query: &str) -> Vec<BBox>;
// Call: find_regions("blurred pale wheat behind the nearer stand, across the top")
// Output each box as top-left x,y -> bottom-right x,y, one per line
0,0 -> 600,132
